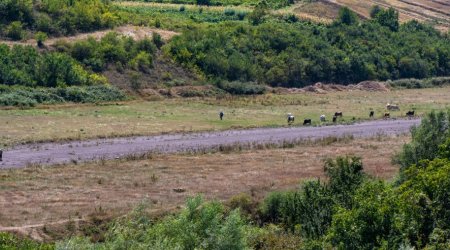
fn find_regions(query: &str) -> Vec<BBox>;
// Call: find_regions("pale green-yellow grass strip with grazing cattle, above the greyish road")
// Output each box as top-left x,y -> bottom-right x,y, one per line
0,87 -> 450,146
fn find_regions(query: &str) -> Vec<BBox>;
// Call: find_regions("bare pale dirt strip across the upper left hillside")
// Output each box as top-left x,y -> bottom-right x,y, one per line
0,25 -> 179,47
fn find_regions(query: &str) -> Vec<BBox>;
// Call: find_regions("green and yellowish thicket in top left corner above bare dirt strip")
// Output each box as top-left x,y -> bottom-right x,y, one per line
0,0 -> 121,40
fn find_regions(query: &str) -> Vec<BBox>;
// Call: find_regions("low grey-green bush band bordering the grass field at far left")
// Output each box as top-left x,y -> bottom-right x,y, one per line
0,85 -> 128,107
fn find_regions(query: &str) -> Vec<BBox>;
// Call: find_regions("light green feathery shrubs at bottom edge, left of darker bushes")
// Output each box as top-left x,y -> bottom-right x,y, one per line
57,197 -> 248,249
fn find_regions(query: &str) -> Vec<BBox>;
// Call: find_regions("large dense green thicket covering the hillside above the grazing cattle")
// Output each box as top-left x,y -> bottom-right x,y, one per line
166,9 -> 450,87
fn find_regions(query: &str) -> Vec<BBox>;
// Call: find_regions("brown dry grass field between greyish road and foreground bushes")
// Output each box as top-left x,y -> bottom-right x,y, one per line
0,136 -> 410,239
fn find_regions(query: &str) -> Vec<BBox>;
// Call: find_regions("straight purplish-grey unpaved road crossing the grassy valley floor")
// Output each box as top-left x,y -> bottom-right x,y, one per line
0,119 -> 420,169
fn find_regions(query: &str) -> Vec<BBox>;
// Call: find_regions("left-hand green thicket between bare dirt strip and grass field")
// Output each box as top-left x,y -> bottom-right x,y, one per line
0,32 -> 159,106
